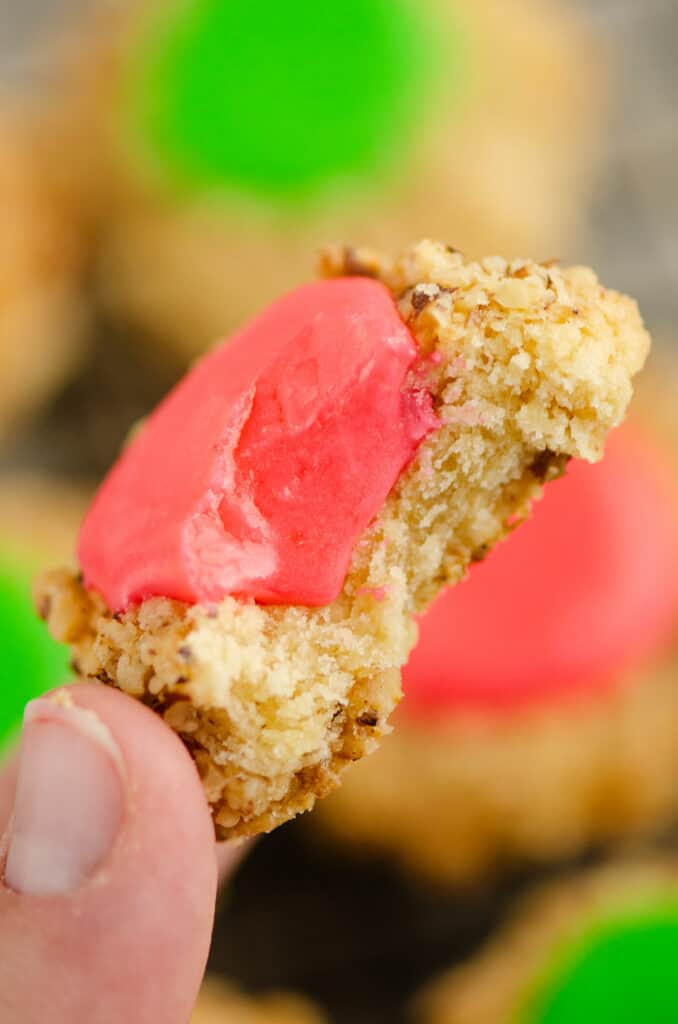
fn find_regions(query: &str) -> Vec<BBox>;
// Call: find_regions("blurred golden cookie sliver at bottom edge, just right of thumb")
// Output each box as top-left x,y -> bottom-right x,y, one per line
190,979 -> 325,1024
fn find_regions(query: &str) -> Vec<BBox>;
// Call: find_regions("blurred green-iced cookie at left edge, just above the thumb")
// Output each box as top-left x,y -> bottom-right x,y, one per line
0,472 -> 86,753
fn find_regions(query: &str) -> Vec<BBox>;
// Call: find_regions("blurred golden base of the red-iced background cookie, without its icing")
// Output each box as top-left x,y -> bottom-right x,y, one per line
313,358 -> 678,884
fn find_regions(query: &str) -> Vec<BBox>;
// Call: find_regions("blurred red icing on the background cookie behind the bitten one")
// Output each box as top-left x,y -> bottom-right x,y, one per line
404,428 -> 678,715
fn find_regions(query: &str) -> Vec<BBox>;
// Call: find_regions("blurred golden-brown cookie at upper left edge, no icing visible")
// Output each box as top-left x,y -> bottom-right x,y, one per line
0,105 -> 85,444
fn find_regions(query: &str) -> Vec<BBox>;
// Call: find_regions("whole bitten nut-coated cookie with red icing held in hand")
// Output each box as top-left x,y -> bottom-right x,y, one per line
37,242 -> 648,838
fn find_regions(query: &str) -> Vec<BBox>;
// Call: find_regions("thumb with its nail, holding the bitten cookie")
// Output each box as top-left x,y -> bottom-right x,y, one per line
0,685 -> 216,1024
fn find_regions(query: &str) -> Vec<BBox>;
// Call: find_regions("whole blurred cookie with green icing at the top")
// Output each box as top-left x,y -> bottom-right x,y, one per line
26,0 -> 604,360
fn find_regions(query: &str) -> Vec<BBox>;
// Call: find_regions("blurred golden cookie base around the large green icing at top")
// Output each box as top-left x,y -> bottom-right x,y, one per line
34,0 -> 605,360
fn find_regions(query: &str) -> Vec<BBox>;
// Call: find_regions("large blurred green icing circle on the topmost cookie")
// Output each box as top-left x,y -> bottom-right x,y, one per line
122,0 -> 463,205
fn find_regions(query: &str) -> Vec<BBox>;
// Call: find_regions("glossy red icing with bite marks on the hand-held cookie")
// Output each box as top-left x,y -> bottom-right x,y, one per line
79,278 -> 437,610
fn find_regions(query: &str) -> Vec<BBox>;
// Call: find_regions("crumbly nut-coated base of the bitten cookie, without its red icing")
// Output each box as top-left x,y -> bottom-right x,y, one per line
37,242 -> 648,838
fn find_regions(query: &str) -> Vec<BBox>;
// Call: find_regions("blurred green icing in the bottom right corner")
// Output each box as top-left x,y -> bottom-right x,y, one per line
516,891 -> 678,1024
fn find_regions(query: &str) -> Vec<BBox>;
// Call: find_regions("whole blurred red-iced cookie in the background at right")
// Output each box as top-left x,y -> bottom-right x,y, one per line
317,361 -> 678,883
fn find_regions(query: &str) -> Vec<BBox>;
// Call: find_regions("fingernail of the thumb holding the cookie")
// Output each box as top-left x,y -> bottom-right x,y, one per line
5,692 -> 124,896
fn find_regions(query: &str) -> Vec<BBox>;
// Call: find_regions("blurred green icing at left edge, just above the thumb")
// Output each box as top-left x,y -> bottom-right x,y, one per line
0,555 -> 70,753
